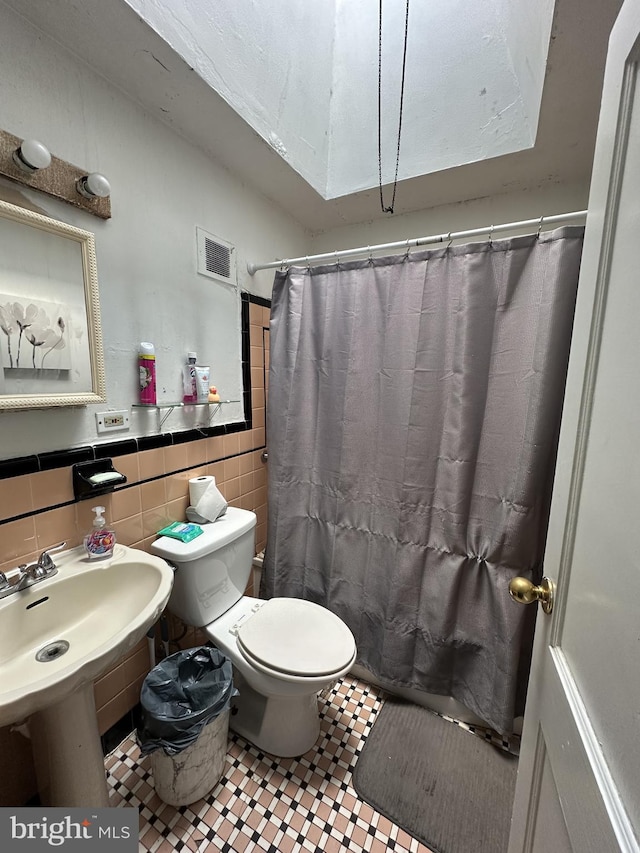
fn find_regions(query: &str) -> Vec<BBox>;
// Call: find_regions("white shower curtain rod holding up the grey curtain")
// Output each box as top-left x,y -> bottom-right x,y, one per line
247,210 -> 587,275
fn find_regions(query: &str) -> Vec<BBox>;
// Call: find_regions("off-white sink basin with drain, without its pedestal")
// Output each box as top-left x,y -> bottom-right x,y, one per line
0,545 -> 173,726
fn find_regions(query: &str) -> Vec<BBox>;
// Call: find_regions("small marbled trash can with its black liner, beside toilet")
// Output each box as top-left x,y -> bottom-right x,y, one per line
137,646 -> 238,806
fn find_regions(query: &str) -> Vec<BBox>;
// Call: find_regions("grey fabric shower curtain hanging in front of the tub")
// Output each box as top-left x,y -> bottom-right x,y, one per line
262,228 -> 583,732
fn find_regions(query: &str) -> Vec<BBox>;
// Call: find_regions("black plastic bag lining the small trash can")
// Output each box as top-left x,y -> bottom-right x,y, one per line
136,646 -> 238,755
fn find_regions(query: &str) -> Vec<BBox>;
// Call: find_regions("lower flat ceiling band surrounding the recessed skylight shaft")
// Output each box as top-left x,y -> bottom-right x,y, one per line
4,0 -> 621,231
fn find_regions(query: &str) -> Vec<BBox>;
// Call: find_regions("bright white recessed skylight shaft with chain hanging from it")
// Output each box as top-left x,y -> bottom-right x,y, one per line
126,0 -> 554,199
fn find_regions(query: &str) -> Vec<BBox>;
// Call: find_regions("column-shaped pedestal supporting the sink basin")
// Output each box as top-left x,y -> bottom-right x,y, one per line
29,682 -> 109,808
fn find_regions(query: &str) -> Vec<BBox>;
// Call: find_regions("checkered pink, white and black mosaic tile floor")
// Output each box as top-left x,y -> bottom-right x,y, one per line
106,677 -> 436,853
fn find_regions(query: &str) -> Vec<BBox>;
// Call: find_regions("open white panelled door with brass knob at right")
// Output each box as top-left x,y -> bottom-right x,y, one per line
509,0 -> 640,853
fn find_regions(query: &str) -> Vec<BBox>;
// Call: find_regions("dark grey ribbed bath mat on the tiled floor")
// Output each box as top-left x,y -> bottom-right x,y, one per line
353,698 -> 518,853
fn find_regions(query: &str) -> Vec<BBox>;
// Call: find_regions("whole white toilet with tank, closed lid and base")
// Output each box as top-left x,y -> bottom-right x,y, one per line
151,507 -> 356,757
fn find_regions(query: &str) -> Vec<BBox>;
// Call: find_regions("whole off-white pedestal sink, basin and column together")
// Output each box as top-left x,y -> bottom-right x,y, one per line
0,545 -> 173,808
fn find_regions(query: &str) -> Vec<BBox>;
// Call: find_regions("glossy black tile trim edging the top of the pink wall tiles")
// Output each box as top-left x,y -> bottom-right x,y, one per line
0,291 -> 271,481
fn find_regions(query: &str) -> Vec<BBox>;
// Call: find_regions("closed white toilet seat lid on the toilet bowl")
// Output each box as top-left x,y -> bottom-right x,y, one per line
237,598 -> 356,678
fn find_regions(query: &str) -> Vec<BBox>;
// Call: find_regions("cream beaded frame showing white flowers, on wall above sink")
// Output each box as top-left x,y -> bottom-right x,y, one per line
0,201 -> 106,410
